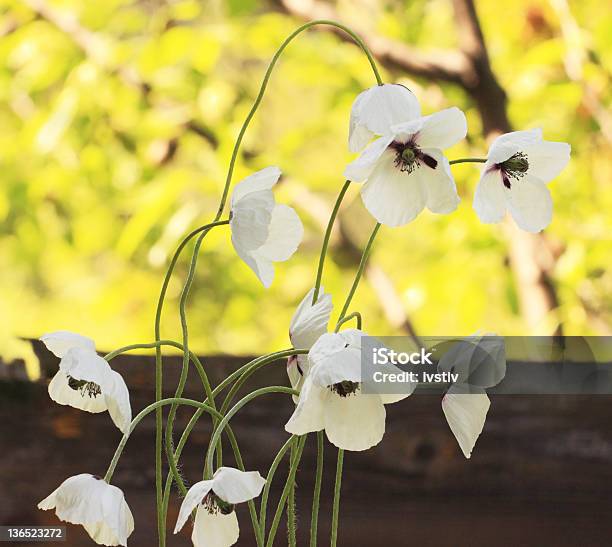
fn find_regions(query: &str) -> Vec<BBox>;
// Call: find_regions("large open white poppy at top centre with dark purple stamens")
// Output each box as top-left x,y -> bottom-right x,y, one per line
344,107 -> 467,226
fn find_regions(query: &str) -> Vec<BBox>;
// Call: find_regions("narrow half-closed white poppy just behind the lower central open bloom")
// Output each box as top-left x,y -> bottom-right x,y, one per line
287,287 -> 333,402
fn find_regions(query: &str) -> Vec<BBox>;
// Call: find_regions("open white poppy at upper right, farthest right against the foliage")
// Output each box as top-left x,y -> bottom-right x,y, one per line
474,129 -> 570,233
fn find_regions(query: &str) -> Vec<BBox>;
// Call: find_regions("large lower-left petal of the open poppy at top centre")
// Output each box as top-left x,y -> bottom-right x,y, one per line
361,152 -> 427,226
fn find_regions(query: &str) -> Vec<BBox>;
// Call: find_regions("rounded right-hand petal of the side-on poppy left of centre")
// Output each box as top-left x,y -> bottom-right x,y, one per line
257,205 -> 304,262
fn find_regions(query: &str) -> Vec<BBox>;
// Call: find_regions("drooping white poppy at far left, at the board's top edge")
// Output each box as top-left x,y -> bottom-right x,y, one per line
40,331 -> 132,434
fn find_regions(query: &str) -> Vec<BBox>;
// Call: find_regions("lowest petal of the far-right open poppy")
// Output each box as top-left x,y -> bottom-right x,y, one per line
507,173 -> 552,233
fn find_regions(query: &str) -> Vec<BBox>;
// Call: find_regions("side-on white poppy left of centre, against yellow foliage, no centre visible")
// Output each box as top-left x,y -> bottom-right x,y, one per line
230,167 -> 304,287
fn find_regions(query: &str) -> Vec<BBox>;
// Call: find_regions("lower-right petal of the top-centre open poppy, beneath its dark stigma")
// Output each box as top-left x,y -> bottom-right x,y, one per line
419,148 -> 460,214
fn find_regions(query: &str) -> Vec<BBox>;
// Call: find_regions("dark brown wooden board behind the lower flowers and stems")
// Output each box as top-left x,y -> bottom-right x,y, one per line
0,347 -> 612,547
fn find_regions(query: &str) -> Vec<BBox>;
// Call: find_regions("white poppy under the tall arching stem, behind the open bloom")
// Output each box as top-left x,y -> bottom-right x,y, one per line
349,84 -> 421,152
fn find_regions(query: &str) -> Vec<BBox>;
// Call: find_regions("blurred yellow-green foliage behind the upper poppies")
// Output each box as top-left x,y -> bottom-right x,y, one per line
0,0 -> 612,366
